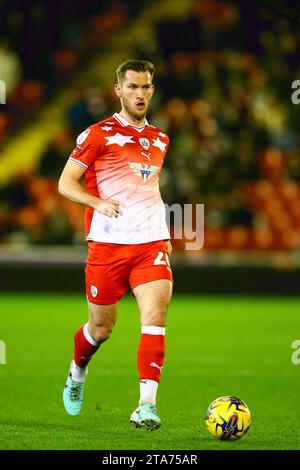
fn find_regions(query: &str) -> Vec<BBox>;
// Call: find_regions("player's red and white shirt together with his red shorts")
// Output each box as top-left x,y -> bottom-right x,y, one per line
70,113 -> 172,304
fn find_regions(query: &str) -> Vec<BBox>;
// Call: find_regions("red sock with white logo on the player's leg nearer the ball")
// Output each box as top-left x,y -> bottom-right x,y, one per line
138,327 -> 166,382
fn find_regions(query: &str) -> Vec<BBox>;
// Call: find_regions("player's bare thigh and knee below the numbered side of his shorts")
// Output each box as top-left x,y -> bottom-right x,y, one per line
133,279 -> 173,326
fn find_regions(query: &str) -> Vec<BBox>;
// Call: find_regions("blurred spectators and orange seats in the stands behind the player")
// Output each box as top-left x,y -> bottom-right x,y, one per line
0,0 -> 300,250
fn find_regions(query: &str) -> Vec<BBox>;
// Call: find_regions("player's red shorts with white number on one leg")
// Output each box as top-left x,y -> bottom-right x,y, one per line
85,240 -> 173,305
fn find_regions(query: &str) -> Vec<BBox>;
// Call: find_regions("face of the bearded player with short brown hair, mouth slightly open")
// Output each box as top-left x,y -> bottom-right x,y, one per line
116,70 -> 154,120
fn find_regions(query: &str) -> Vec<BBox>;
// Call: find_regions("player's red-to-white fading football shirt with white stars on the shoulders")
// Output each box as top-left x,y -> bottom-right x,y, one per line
70,113 -> 170,244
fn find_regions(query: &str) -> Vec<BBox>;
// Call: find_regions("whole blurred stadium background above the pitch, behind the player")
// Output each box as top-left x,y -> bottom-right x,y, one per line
0,0 -> 300,293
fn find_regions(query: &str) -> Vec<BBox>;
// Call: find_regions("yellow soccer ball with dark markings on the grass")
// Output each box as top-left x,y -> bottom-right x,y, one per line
205,397 -> 251,441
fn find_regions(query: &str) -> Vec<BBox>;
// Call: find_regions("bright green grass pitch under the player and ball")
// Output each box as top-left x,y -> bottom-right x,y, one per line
0,294 -> 300,450
